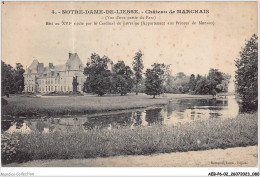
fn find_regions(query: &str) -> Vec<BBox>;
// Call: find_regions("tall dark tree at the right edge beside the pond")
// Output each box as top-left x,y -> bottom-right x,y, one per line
235,34 -> 258,110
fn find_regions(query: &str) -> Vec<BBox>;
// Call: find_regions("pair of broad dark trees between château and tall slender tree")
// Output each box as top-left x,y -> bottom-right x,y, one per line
84,54 -> 134,96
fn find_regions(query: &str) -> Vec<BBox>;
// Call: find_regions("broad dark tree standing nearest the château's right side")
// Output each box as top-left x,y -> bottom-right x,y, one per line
84,53 -> 112,96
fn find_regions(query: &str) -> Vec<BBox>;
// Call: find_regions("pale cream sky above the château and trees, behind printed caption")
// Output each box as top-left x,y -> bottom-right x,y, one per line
1,2 -> 258,80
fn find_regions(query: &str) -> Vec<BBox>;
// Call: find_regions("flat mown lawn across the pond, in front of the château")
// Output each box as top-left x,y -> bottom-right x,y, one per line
2,94 -> 212,117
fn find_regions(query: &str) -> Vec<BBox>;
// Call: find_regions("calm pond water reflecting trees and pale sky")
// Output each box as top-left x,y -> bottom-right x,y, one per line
2,96 -> 239,133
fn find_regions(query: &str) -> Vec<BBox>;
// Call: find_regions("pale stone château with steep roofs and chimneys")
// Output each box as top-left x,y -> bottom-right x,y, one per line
24,53 -> 86,93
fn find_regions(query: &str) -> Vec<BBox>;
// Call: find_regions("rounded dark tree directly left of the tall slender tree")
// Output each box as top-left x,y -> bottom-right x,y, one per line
113,61 -> 133,96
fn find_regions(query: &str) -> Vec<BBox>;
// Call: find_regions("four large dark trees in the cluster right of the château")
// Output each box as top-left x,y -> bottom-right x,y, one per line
83,51 -> 175,98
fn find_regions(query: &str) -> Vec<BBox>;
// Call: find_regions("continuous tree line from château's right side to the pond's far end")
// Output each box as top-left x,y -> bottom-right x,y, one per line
84,51 -> 231,98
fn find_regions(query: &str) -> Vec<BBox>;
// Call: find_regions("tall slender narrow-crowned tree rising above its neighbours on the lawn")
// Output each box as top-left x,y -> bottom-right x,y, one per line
132,50 -> 144,95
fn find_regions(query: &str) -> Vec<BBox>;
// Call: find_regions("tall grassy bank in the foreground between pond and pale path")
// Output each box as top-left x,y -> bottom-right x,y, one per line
2,113 -> 258,163
